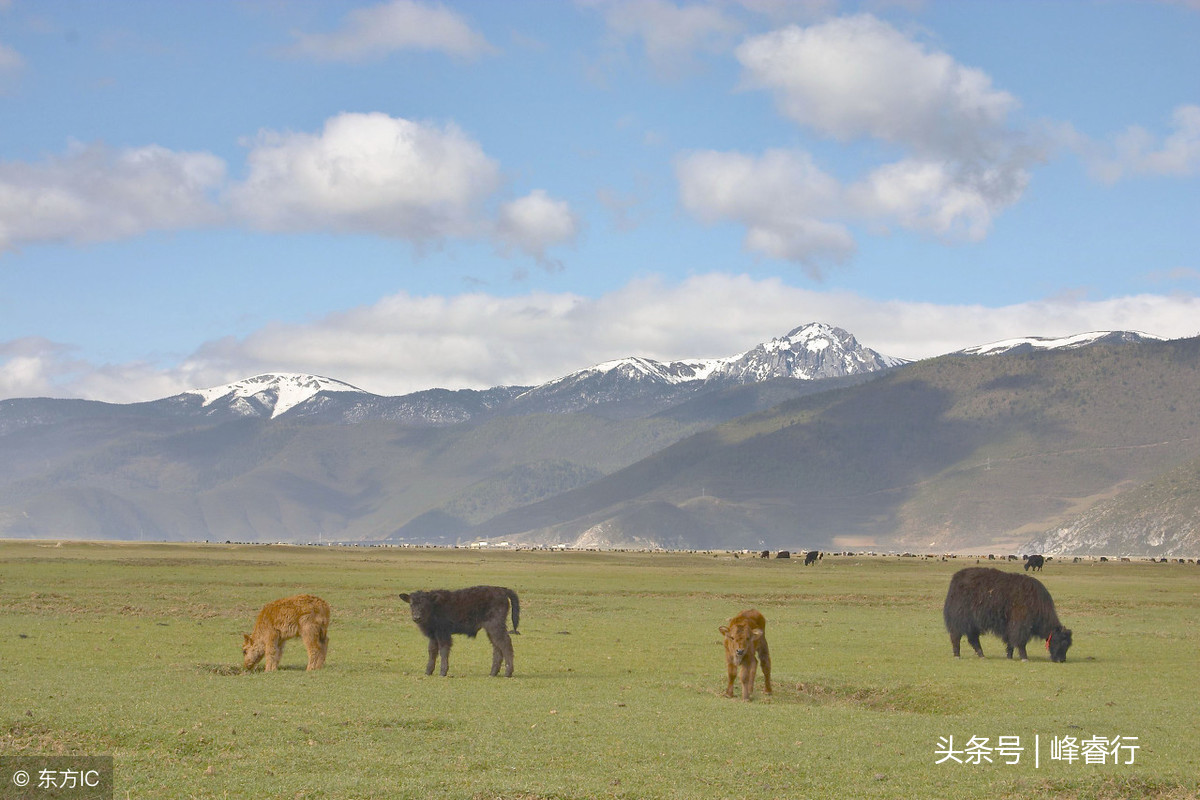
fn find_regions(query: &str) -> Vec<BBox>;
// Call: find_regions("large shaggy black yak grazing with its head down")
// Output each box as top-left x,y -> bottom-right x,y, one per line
942,566 -> 1070,662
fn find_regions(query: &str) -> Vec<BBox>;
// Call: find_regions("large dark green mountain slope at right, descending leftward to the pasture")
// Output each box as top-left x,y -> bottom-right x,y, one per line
451,339 -> 1200,552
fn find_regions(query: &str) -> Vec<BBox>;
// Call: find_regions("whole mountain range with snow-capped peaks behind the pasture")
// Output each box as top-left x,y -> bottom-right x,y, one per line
0,324 -> 1200,555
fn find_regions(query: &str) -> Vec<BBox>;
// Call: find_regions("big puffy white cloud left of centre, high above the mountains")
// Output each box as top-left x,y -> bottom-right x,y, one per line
229,113 -> 500,242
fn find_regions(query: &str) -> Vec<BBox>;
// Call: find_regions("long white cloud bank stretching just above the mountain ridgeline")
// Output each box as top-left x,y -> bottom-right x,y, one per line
11,273 -> 1200,402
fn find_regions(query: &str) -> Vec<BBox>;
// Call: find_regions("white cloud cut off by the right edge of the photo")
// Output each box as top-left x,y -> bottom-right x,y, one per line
1084,104 -> 1200,184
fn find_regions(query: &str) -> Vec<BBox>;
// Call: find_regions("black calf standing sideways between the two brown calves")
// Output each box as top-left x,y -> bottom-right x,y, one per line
400,587 -> 521,678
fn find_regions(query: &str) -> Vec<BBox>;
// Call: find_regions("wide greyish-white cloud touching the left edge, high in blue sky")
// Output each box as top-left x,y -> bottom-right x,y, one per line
0,144 -> 226,252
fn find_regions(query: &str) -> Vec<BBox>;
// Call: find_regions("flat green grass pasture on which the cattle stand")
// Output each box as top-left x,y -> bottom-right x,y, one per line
0,542 -> 1200,800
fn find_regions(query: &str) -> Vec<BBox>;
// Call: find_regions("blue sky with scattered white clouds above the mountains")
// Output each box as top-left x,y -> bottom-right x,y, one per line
0,0 -> 1200,402
